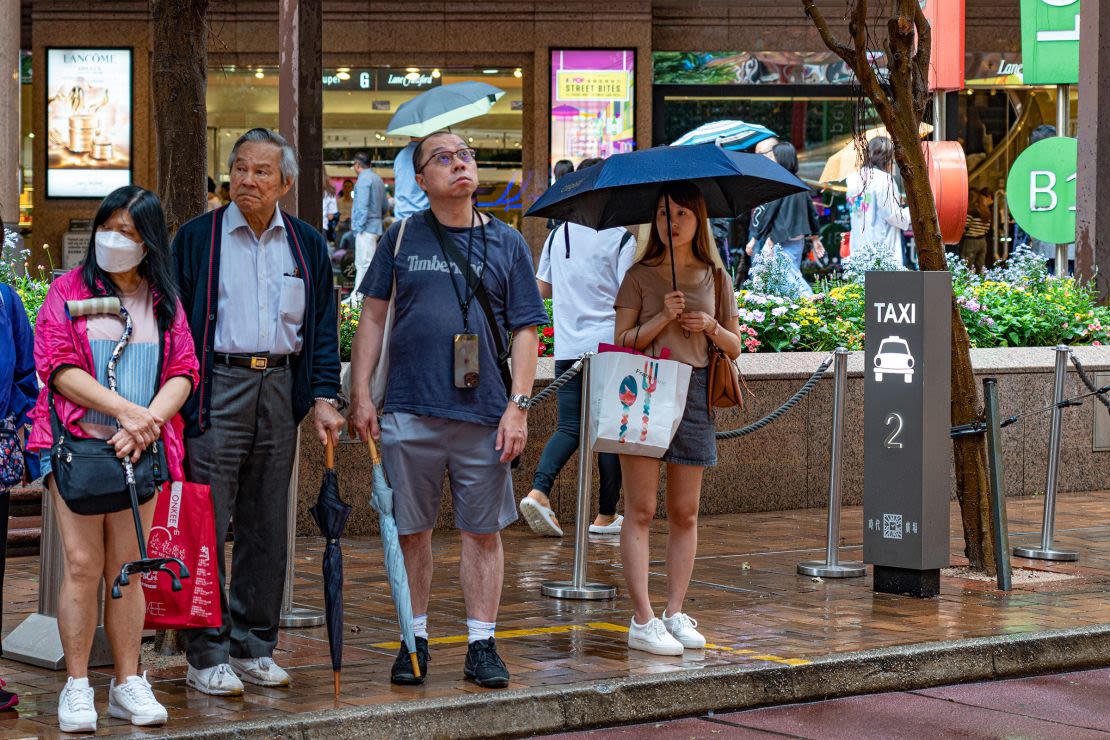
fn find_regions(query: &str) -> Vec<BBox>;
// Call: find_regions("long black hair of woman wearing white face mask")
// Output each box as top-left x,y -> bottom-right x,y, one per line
81,185 -> 179,332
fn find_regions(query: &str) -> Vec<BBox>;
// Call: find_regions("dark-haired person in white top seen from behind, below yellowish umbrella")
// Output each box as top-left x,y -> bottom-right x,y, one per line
847,136 -> 910,264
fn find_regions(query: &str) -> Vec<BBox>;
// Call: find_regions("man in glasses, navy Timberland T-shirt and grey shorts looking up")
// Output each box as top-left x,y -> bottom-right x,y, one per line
351,132 -> 547,688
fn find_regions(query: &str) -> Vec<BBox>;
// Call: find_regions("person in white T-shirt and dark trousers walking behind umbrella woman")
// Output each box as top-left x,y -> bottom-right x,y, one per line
521,159 -> 636,537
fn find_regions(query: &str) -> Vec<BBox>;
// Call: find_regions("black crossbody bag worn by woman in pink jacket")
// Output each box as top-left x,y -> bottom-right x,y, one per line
50,393 -> 170,515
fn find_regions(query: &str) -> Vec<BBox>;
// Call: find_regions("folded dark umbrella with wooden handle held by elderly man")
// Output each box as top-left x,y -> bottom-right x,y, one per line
309,439 -> 351,697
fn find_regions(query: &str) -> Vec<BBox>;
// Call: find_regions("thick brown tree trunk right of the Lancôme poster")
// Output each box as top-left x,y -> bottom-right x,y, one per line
150,0 -> 209,234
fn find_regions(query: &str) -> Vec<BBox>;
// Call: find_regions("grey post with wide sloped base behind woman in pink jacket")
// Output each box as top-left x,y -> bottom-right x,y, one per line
3,488 -> 113,670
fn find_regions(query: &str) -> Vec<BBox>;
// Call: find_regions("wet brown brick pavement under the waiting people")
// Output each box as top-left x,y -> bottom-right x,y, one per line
0,494 -> 1110,738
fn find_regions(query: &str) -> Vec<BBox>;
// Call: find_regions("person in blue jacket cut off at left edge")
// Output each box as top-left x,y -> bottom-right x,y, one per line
0,221 -> 39,711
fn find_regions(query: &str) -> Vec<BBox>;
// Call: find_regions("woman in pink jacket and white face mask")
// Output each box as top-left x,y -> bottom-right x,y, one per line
28,185 -> 198,732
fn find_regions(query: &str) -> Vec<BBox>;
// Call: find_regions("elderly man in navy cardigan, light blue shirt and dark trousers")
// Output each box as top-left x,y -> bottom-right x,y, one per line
173,129 -> 344,696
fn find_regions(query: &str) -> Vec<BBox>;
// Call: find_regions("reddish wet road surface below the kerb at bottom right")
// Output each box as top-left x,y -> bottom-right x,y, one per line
549,669 -> 1110,740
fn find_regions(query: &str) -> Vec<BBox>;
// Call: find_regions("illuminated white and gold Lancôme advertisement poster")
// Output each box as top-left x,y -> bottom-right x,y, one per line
47,49 -> 132,199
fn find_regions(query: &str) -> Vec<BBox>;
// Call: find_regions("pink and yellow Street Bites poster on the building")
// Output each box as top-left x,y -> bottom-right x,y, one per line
551,49 -> 636,166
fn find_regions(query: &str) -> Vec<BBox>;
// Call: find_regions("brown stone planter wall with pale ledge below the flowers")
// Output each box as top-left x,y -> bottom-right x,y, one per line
297,347 -> 1110,535
